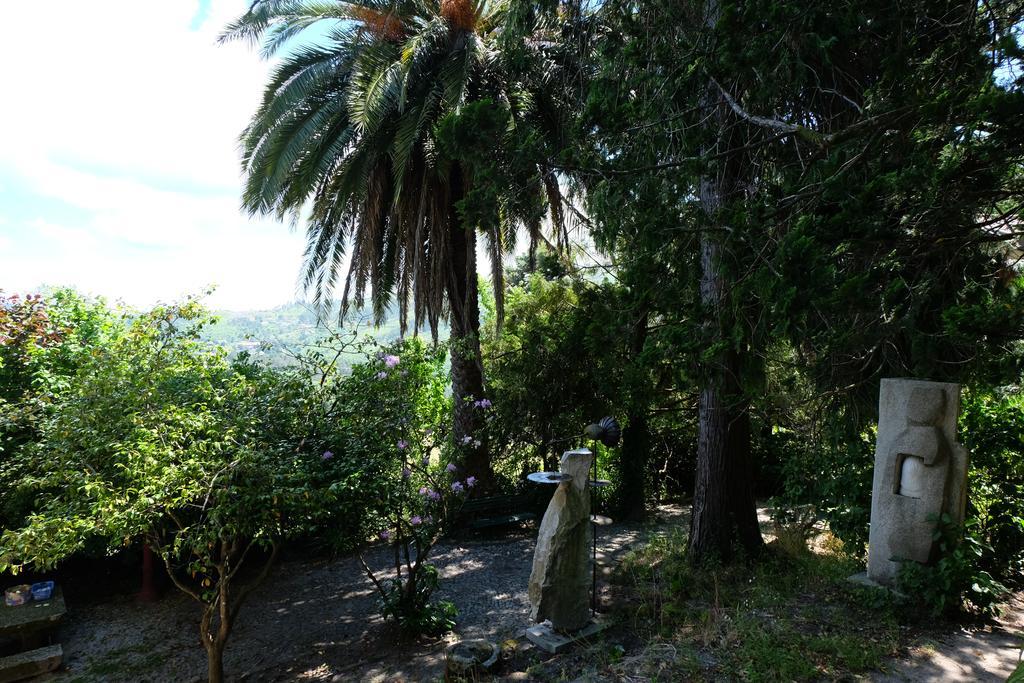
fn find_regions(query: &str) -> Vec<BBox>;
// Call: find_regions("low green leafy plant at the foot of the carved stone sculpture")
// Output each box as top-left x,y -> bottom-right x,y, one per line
896,513 -> 1010,616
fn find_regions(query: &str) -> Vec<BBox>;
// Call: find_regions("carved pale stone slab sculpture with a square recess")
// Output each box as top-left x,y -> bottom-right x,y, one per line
867,379 -> 967,586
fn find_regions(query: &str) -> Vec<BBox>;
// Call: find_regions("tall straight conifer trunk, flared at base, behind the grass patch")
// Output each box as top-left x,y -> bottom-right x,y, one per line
689,14 -> 763,563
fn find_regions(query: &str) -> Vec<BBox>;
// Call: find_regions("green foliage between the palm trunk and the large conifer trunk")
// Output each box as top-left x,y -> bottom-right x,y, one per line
483,272 -> 692,507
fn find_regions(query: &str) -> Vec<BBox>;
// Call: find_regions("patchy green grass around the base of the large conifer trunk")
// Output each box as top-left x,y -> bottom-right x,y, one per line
616,533 -> 907,681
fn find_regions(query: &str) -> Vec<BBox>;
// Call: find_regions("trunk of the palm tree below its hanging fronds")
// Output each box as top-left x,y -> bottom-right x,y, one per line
447,168 -> 494,492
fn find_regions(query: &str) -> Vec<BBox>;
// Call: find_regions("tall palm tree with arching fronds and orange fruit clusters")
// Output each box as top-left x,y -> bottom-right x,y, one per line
221,0 -> 564,482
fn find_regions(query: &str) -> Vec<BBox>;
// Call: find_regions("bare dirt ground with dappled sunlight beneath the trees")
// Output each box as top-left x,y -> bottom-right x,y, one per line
34,507 -> 1024,682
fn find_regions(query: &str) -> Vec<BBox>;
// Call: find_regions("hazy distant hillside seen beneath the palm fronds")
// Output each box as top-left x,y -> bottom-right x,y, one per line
203,302 -> 447,365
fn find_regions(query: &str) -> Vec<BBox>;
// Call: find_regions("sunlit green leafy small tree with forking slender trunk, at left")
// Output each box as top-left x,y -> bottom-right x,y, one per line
0,301 -> 336,681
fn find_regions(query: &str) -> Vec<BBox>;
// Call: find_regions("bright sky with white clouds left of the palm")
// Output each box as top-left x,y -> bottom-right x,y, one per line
0,0 -> 311,310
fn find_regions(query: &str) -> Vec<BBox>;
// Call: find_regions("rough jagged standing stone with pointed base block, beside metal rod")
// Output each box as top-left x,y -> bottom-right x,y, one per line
529,449 -> 594,632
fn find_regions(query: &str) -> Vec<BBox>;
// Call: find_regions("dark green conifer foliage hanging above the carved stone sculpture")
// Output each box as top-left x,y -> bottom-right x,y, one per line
560,0 -> 1024,556
